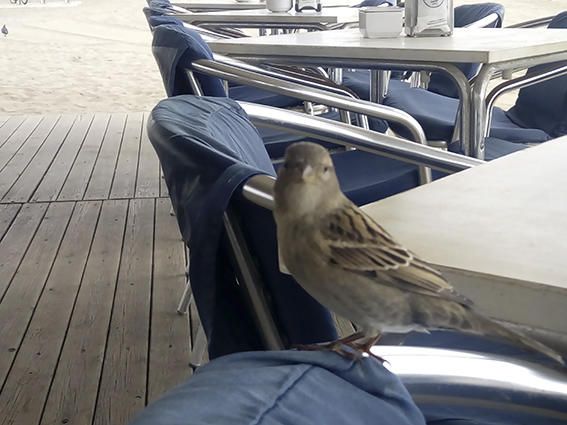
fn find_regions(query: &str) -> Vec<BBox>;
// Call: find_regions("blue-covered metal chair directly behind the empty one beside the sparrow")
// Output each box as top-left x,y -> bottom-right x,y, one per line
153,25 -> 434,205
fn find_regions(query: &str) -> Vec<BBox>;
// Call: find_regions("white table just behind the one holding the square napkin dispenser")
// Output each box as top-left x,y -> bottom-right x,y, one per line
178,7 -> 358,29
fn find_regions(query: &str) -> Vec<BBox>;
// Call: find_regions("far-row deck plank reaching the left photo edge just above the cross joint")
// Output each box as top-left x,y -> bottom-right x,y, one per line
0,115 -> 59,199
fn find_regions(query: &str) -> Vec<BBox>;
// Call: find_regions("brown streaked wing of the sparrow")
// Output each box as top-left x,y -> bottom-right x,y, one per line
320,205 -> 470,304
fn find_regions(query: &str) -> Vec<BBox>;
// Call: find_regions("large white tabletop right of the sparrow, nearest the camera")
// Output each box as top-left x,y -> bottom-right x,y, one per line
364,137 -> 567,334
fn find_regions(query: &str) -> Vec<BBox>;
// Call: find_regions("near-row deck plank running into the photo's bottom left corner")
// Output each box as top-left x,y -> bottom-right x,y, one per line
0,202 -> 101,424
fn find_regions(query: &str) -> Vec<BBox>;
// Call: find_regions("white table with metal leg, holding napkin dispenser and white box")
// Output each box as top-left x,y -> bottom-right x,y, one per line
210,28 -> 567,158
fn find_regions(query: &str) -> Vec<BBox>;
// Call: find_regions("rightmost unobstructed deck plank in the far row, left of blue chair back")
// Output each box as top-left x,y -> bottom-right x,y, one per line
110,112 -> 144,199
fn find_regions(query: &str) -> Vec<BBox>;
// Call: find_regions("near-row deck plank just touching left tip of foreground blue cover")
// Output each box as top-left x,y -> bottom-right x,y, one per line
93,199 -> 154,425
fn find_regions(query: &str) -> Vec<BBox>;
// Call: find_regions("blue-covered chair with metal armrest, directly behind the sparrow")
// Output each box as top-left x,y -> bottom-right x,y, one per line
148,96 -> 481,358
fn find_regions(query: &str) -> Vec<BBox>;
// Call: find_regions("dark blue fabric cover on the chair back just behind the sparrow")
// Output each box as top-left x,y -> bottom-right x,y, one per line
148,96 -> 342,358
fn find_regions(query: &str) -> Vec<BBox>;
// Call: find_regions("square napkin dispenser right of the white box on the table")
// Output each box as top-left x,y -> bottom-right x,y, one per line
405,0 -> 454,37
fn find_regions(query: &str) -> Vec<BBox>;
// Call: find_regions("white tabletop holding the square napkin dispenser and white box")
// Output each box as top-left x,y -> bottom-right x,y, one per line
210,26 -> 567,63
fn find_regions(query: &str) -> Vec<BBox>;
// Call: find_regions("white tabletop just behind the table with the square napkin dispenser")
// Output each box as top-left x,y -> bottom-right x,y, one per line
179,7 -> 358,24
